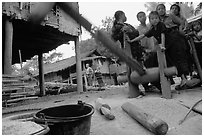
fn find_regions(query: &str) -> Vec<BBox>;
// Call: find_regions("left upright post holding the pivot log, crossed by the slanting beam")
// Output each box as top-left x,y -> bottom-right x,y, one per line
123,33 -> 140,98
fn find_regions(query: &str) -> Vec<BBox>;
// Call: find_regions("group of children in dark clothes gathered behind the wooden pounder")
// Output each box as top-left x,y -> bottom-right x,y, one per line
112,4 -> 202,95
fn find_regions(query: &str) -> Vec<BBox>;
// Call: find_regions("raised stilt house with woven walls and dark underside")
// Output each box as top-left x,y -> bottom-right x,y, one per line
2,2 -> 82,96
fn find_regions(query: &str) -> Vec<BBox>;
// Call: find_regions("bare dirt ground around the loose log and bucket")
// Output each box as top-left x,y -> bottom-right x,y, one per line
2,85 -> 202,135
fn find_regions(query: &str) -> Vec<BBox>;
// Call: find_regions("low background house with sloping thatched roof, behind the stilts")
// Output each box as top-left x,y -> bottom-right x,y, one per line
34,49 -> 126,85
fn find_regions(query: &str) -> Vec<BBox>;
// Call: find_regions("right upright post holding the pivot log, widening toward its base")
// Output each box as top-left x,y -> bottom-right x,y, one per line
157,45 -> 171,99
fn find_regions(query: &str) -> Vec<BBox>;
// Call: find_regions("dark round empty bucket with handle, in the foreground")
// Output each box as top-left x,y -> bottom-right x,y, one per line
34,101 -> 94,135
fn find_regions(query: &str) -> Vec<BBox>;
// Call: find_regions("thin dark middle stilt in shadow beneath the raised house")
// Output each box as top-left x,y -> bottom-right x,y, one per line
38,53 -> 45,96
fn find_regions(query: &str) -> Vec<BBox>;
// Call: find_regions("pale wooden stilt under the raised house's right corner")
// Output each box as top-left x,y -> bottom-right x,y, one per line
75,37 -> 83,93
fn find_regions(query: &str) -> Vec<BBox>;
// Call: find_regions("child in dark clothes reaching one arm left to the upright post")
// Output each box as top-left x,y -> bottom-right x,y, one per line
129,11 -> 189,88
